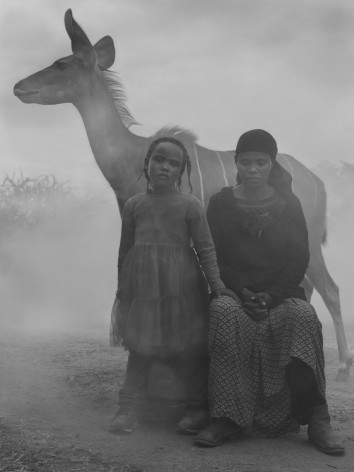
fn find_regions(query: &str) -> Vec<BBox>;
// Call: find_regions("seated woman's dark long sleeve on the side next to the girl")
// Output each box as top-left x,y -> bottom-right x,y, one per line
207,195 -> 253,294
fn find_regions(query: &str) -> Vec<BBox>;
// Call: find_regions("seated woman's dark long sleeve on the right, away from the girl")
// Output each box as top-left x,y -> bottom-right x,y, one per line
266,197 -> 310,299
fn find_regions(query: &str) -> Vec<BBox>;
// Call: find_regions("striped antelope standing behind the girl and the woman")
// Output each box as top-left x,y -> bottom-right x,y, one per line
14,9 -> 352,381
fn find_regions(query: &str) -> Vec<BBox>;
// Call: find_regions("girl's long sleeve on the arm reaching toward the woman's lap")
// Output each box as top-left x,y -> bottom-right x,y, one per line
186,199 -> 225,292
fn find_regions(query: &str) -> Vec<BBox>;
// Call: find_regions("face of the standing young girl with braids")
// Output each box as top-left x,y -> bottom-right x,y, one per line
148,141 -> 183,193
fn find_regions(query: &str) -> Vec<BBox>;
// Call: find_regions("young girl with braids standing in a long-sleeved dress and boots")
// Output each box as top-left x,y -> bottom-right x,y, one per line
110,137 -> 224,433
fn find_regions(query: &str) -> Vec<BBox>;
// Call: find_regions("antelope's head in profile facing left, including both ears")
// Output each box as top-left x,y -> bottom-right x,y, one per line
14,9 -> 115,105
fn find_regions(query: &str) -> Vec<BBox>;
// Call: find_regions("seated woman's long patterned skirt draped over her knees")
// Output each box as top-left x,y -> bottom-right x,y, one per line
209,296 -> 325,437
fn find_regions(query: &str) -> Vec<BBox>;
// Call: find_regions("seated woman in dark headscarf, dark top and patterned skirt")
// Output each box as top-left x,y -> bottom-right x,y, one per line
195,130 -> 344,454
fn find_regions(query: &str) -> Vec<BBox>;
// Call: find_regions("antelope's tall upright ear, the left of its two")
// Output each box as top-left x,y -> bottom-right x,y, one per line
64,9 -> 96,65
